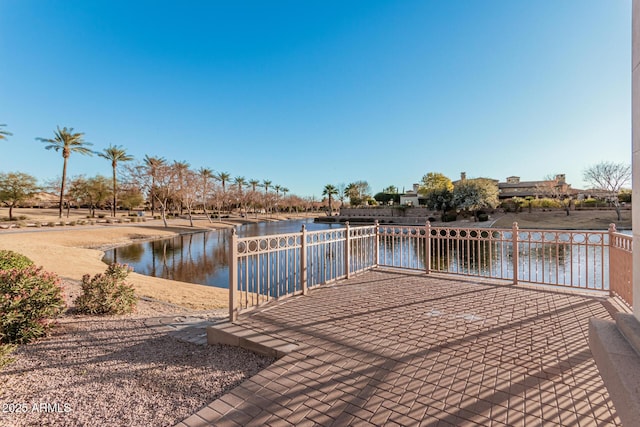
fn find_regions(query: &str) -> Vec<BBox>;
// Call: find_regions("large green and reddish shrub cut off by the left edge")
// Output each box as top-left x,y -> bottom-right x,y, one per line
0,265 -> 65,344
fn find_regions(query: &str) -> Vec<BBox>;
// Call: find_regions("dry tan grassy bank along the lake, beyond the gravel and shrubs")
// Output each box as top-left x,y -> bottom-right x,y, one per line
0,212 -> 318,311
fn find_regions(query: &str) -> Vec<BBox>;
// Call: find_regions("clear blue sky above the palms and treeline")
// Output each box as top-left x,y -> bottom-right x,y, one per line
0,0 -> 631,198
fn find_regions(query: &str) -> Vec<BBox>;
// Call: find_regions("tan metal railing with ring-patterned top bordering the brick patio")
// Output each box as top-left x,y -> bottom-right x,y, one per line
229,223 -> 632,320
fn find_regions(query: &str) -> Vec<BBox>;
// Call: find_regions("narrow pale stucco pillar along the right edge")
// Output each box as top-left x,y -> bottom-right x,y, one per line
631,0 -> 640,320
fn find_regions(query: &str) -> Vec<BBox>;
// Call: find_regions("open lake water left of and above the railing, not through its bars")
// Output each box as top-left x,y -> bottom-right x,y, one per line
103,219 -> 342,288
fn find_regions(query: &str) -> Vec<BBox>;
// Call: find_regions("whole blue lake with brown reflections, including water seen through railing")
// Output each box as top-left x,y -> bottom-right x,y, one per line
104,220 -> 608,293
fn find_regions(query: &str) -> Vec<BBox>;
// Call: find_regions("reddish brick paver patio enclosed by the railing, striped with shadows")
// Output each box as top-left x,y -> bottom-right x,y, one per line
178,270 -> 620,427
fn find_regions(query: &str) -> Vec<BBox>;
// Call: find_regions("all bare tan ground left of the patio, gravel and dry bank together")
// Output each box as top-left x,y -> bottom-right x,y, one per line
0,210 -> 328,427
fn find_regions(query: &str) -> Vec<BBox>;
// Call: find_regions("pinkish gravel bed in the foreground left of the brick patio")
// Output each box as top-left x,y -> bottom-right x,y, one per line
0,283 -> 273,427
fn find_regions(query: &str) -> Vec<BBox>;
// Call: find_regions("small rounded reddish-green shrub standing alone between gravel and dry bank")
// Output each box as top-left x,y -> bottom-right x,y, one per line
76,264 -> 137,314
